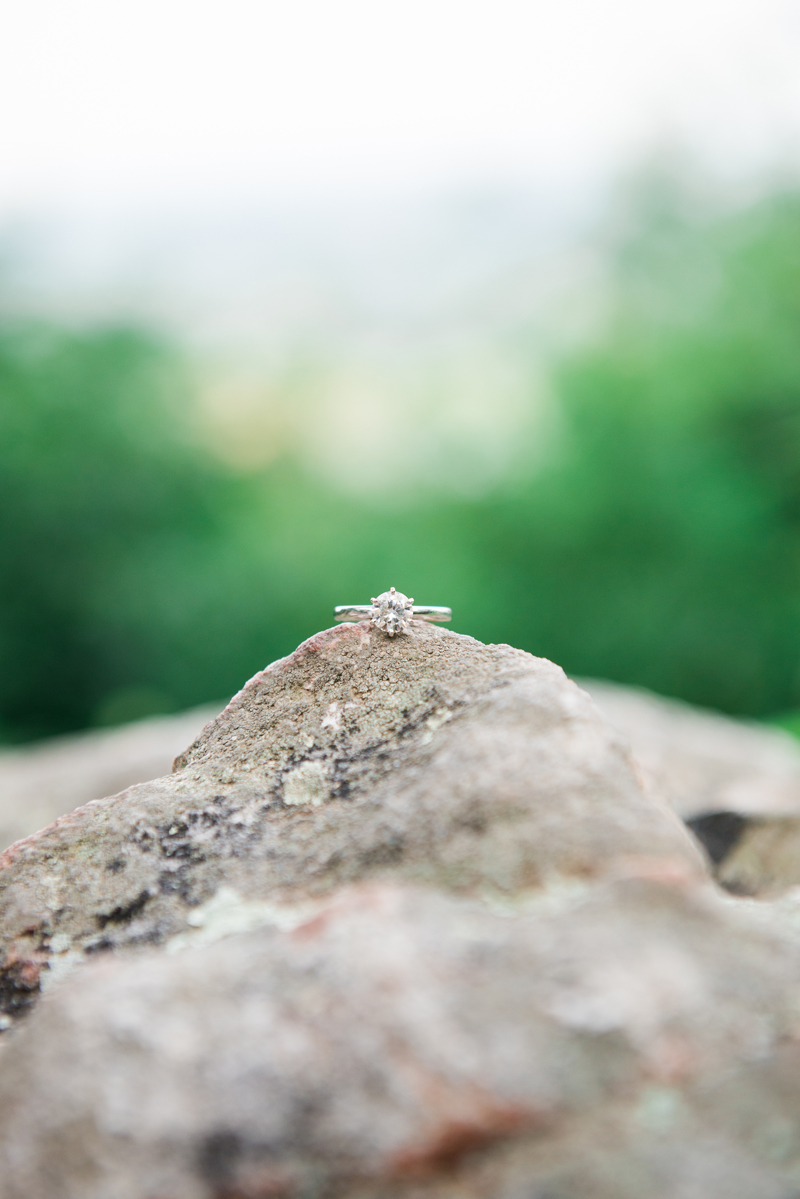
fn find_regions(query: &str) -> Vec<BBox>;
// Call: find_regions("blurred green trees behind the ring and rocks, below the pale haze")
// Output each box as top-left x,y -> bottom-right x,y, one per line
0,175 -> 800,741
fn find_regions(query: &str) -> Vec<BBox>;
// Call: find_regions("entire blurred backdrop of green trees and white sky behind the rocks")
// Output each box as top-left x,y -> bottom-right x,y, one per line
0,0 -> 800,743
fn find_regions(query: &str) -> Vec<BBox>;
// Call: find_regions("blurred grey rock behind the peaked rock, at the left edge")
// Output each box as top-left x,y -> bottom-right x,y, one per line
0,707 -> 219,851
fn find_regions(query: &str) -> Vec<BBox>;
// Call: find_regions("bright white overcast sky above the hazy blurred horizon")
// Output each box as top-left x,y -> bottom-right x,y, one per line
0,0 -> 800,216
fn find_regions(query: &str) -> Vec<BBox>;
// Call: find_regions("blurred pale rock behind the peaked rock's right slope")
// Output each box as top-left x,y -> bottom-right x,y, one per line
578,679 -> 800,820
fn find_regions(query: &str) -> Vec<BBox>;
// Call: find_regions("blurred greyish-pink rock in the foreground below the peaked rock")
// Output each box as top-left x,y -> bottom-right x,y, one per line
0,863 -> 800,1199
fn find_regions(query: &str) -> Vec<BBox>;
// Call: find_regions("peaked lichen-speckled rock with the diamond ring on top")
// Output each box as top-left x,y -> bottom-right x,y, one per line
0,622 -> 706,1019
